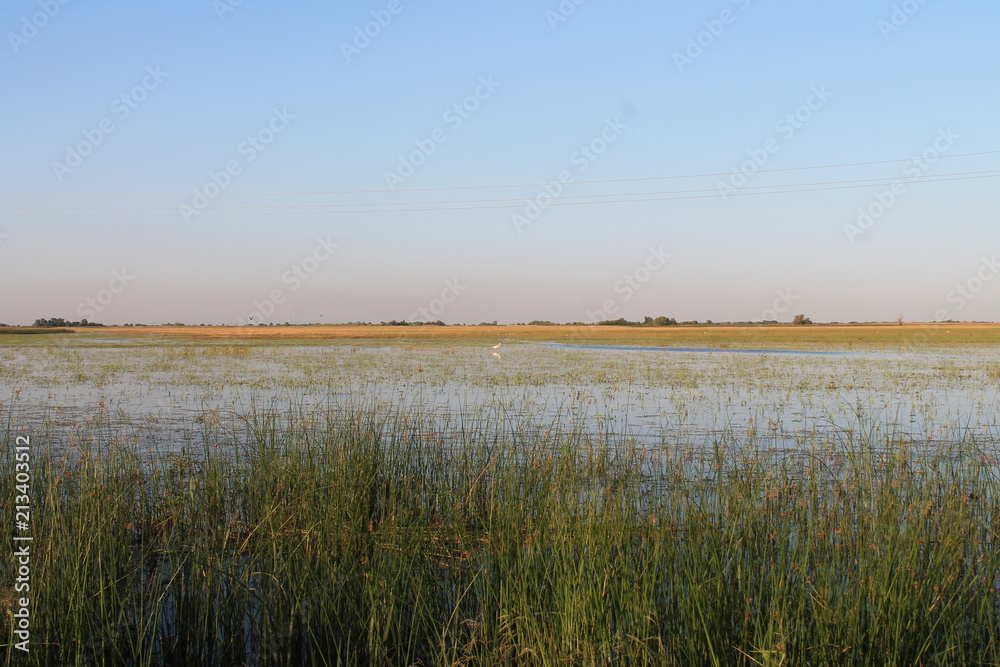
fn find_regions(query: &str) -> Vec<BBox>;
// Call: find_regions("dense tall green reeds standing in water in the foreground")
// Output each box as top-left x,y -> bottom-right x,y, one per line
0,406 -> 1000,665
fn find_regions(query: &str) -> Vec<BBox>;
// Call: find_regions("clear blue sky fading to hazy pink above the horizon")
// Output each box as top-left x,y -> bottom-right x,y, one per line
0,0 -> 1000,324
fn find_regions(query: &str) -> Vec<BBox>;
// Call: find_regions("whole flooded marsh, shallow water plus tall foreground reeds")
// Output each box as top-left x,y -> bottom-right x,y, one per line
0,327 -> 1000,665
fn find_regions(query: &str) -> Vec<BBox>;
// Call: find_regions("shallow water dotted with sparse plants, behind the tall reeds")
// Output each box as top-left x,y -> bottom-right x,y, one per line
0,337 -> 1000,451
